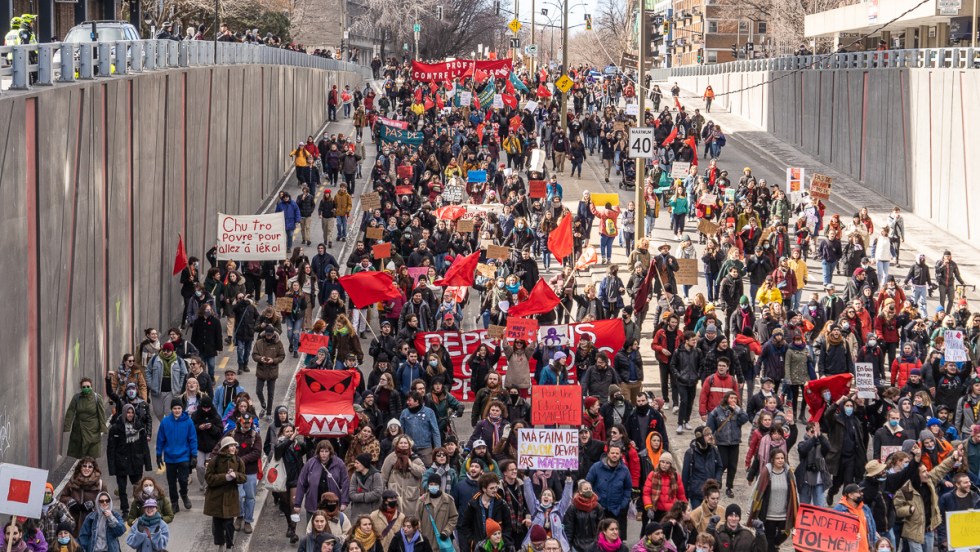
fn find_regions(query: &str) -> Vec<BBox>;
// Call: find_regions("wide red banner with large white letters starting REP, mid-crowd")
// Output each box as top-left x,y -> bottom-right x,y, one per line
415,318 -> 626,401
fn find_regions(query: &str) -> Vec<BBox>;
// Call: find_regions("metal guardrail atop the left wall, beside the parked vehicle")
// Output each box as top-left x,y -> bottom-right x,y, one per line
0,40 -> 371,90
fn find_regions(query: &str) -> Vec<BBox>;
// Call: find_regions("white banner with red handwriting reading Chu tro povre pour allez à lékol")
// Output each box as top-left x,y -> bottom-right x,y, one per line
215,213 -> 289,261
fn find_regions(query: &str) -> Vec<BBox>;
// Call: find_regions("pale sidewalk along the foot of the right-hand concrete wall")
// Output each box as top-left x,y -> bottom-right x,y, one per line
668,85 -> 980,303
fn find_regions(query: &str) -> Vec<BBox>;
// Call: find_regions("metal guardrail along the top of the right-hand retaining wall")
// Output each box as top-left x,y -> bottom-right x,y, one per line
668,48 -> 980,77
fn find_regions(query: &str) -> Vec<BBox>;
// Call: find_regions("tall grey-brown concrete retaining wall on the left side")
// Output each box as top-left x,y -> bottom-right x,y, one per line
0,66 -> 361,467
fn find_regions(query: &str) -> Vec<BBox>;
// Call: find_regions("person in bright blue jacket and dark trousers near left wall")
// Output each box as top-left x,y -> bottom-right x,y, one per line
157,399 -> 197,513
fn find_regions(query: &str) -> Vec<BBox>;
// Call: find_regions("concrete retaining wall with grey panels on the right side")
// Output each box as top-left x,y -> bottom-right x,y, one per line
669,68 -> 980,240
